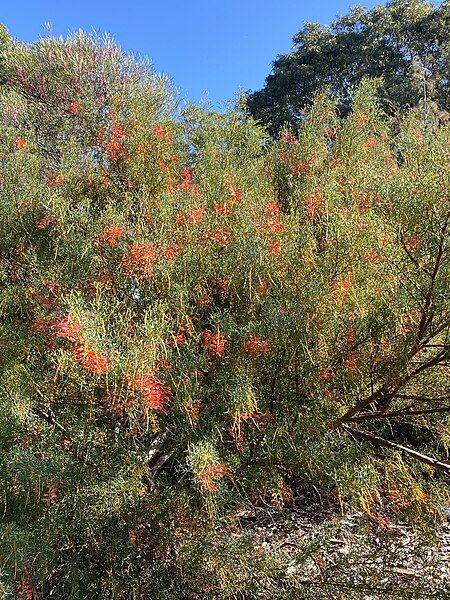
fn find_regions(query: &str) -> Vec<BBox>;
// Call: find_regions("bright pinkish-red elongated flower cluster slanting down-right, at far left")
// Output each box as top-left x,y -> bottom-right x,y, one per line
52,316 -> 110,376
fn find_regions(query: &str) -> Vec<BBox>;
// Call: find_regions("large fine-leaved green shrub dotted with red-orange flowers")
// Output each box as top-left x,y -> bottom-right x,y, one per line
0,29 -> 450,600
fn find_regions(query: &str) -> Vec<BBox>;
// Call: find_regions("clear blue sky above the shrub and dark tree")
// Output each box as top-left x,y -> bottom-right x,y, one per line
0,0 -> 384,108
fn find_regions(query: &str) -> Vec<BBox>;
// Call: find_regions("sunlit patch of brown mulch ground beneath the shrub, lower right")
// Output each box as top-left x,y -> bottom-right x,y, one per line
237,490 -> 450,600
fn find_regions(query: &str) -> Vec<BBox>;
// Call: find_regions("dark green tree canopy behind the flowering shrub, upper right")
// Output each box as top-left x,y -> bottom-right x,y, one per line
248,0 -> 450,133
